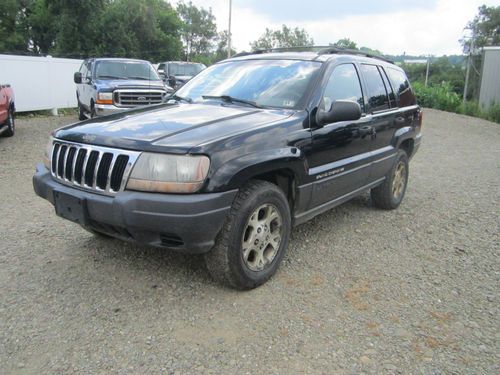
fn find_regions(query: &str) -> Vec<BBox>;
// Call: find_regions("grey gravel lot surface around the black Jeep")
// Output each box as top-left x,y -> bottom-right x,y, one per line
0,110 -> 500,374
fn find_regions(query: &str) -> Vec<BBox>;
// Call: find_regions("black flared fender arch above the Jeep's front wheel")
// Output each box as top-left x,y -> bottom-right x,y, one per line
207,147 -> 307,191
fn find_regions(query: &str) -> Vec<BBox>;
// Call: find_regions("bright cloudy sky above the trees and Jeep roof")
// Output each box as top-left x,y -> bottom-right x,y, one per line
172,0 -> 500,55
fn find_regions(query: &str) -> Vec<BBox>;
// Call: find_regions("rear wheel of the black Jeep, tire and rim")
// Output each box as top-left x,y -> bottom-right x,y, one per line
370,150 -> 409,210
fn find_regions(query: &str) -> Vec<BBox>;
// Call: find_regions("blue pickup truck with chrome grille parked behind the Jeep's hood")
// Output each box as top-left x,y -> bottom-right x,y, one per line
74,58 -> 173,120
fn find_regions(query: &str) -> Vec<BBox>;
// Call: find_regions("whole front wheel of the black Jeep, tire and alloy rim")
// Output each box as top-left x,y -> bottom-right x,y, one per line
205,180 -> 291,290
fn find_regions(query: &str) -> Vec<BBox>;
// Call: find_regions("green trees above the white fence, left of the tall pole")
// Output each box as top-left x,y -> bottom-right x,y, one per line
0,0 -> 227,63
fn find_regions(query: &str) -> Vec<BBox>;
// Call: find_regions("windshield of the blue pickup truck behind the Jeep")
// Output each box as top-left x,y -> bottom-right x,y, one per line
95,61 -> 160,81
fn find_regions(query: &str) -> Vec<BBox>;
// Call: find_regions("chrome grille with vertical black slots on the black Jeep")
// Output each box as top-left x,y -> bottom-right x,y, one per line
51,140 -> 140,195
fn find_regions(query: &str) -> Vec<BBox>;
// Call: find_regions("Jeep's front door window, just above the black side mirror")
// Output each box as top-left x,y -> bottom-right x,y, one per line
323,64 -> 364,112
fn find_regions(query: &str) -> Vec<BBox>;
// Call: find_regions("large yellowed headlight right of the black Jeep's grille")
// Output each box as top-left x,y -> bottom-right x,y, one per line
127,152 -> 210,193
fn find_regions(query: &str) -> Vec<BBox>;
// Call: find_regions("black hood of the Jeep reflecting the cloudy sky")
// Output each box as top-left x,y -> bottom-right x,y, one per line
54,102 -> 293,153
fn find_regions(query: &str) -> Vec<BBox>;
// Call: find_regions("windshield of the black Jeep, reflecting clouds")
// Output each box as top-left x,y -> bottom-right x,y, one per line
177,60 -> 321,108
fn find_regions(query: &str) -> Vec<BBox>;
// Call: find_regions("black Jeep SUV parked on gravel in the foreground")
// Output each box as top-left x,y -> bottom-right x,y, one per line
33,48 -> 422,289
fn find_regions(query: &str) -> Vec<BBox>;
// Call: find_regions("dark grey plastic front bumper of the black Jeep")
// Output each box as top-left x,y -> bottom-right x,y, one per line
33,164 -> 237,253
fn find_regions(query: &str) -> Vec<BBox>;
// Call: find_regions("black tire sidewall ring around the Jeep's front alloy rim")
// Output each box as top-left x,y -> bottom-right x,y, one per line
227,188 -> 291,288
